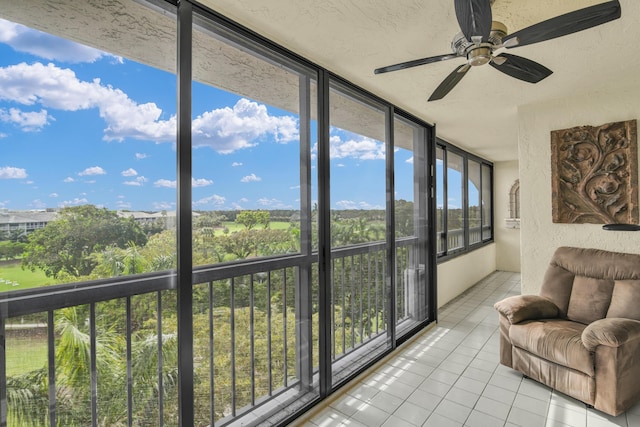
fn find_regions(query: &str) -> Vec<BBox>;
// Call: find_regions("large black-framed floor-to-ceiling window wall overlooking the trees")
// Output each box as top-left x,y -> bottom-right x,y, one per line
0,0 -> 435,426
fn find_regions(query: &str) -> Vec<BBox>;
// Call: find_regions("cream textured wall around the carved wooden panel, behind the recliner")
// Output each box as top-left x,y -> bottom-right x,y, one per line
518,88 -> 640,294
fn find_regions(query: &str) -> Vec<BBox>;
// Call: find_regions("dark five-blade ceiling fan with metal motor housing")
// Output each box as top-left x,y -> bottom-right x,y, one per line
374,0 -> 621,101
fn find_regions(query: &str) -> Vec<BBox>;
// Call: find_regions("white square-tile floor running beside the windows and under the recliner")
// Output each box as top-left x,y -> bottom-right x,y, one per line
299,272 -> 640,427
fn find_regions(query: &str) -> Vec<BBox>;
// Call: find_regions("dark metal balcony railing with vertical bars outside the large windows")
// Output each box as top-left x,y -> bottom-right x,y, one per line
0,238 -> 424,426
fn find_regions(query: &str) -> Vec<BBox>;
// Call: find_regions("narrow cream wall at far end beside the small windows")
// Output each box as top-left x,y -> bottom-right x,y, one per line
493,161 -> 520,272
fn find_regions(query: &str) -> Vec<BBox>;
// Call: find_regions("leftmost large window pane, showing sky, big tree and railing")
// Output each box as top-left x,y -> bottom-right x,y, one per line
0,2 -> 177,426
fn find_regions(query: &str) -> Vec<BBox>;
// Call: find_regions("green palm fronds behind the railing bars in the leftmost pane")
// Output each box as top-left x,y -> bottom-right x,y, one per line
7,306 -> 177,427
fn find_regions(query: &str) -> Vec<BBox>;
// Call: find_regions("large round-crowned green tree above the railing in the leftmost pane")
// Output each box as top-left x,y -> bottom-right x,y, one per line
22,205 -> 147,278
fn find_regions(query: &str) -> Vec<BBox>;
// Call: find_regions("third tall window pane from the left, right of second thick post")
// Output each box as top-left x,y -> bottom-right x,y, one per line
329,82 -> 390,385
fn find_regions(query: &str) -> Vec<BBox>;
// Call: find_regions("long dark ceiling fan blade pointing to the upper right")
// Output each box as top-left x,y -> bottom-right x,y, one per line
503,0 -> 621,46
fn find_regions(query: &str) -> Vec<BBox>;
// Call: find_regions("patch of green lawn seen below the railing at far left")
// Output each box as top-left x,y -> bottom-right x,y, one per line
6,334 -> 47,376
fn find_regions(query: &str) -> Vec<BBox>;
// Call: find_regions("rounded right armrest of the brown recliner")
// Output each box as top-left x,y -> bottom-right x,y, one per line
582,317 -> 640,351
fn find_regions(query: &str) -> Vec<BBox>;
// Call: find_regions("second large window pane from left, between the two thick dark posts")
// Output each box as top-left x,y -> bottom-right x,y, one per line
192,10 -> 319,426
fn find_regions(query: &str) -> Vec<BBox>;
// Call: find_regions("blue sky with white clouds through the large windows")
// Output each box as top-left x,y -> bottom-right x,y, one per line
0,20 -> 413,211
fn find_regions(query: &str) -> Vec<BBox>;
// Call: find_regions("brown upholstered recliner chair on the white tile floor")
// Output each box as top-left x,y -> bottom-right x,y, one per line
494,247 -> 640,416
